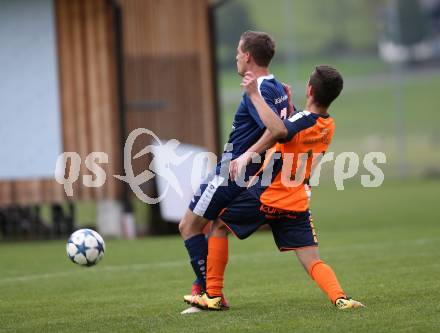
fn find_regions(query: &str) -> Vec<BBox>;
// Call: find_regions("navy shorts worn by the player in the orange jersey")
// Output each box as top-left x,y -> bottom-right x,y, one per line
220,191 -> 318,251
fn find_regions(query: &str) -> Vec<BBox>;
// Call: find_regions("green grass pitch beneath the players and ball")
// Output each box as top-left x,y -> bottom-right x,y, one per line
0,181 -> 440,332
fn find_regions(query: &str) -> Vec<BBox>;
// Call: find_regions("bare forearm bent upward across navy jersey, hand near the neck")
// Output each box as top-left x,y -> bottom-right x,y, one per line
241,72 -> 287,139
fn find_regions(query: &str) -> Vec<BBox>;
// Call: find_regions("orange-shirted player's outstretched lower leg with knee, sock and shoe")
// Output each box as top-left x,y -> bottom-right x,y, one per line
296,246 -> 364,310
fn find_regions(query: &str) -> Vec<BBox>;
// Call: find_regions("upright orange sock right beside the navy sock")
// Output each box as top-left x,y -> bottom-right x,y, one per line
206,237 -> 228,296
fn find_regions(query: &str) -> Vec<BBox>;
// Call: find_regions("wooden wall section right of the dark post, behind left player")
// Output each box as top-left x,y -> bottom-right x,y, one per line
119,0 -> 218,155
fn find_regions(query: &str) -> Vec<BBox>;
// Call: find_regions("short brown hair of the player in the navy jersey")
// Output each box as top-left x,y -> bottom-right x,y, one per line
240,30 -> 275,67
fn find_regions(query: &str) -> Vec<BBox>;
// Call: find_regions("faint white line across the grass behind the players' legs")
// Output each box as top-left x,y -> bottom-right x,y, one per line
0,238 -> 439,285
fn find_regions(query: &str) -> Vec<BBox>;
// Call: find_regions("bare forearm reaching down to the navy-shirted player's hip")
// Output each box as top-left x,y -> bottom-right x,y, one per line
229,129 -> 277,180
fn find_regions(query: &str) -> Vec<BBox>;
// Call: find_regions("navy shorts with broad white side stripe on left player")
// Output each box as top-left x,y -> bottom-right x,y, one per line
189,163 -> 261,220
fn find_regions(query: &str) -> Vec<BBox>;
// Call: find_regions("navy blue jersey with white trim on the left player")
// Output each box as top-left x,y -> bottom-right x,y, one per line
228,75 -> 289,159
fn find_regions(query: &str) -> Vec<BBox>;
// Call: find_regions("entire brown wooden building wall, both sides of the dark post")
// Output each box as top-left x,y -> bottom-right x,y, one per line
0,0 -> 218,206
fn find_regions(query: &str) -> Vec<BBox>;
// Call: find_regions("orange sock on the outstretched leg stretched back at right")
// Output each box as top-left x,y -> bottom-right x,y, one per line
309,260 -> 346,303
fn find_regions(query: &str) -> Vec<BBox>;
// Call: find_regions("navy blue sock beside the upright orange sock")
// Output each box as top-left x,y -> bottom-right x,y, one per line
185,234 -> 208,289
